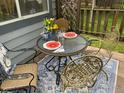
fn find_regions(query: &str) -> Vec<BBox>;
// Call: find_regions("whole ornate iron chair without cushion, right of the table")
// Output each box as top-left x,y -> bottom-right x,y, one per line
61,31 -> 119,90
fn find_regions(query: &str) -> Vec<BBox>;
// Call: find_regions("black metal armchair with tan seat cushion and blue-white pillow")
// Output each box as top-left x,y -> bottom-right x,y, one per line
0,44 -> 37,93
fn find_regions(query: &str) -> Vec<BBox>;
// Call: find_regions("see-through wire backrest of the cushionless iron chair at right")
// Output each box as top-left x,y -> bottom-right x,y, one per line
100,31 -> 119,66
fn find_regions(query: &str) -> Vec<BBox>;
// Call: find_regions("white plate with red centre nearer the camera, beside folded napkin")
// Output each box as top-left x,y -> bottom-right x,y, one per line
43,41 -> 61,50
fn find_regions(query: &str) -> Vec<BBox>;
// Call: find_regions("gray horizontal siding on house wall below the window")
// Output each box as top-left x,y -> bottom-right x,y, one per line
0,0 -> 55,64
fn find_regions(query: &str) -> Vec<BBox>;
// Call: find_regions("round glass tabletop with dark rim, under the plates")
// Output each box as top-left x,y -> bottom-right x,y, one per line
37,35 -> 89,56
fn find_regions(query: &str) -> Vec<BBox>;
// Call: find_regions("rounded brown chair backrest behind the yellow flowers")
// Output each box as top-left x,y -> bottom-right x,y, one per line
55,18 -> 69,32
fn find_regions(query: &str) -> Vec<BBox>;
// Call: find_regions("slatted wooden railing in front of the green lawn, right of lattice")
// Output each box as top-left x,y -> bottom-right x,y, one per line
80,8 -> 124,38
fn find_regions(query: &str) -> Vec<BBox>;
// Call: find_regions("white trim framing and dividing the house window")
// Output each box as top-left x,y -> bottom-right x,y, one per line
0,0 -> 50,26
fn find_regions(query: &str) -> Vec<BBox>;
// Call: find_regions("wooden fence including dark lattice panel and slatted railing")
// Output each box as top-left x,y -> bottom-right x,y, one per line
57,0 -> 124,37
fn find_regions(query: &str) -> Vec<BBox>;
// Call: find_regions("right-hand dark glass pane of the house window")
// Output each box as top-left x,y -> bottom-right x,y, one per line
19,0 -> 47,16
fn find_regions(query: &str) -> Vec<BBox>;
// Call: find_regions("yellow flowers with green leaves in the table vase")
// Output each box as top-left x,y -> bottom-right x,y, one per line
43,18 -> 59,31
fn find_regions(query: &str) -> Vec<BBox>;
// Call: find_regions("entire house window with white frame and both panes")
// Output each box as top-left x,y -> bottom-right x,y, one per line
0,0 -> 49,25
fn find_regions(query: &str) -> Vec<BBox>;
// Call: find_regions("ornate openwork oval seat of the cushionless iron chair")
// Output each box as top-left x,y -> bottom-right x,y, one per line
61,56 -> 103,91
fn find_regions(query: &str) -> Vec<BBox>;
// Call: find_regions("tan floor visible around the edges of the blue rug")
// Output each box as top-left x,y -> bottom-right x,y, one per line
35,47 -> 124,93
